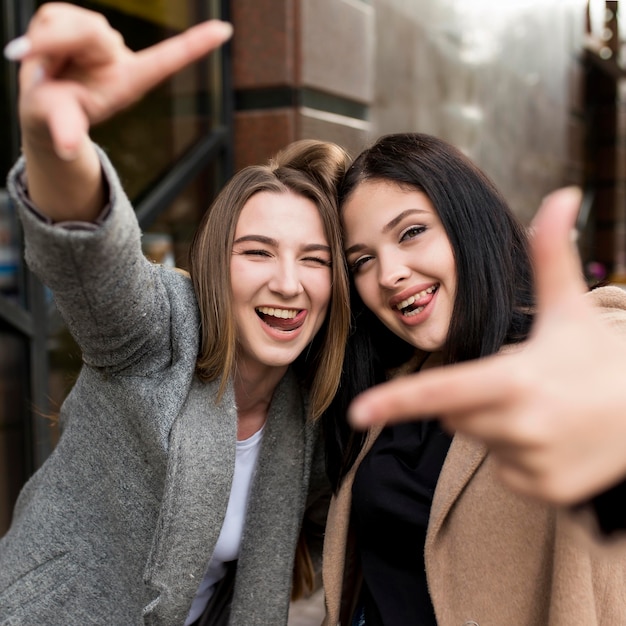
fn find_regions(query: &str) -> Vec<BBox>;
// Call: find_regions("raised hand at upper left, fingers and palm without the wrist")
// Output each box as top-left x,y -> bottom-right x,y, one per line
5,2 -> 232,160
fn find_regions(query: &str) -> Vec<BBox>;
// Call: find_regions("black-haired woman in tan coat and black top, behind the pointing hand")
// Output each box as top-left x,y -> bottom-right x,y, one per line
324,134 -> 626,626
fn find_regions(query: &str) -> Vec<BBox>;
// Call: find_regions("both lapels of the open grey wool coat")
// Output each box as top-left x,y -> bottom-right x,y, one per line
144,371 -> 317,624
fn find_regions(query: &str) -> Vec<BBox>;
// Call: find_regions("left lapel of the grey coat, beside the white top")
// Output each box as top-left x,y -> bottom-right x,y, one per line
144,379 -> 237,625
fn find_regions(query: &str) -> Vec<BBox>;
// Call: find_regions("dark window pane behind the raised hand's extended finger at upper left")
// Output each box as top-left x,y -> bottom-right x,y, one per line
76,0 -> 220,201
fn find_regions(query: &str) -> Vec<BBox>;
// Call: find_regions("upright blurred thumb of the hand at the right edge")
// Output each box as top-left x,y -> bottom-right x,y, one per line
531,187 -> 586,315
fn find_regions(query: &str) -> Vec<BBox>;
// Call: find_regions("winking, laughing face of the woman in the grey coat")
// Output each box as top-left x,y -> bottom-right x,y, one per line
230,191 -> 331,372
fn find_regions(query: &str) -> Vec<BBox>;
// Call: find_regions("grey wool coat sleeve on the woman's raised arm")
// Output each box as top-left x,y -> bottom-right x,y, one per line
8,144 -> 170,374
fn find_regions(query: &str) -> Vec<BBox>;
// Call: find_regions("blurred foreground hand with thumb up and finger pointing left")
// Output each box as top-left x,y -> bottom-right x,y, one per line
350,189 -> 626,504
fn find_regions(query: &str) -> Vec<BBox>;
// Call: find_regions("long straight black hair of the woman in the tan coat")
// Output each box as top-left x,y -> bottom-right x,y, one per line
323,133 -> 534,488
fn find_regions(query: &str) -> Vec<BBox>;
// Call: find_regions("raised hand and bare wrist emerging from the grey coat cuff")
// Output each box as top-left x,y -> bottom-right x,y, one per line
5,2 -> 232,220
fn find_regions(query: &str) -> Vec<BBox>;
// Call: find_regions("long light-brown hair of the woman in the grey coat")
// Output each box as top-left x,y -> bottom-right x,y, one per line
189,140 -> 350,419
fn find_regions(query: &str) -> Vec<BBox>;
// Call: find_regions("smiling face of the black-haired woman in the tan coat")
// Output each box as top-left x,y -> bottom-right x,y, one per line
342,180 -> 456,352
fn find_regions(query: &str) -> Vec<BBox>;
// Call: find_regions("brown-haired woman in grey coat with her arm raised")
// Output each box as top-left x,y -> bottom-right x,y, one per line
0,3 -> 349,626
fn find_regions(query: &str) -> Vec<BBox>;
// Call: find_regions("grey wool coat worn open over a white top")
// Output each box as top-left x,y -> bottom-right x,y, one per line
0,155 -> 328,626
